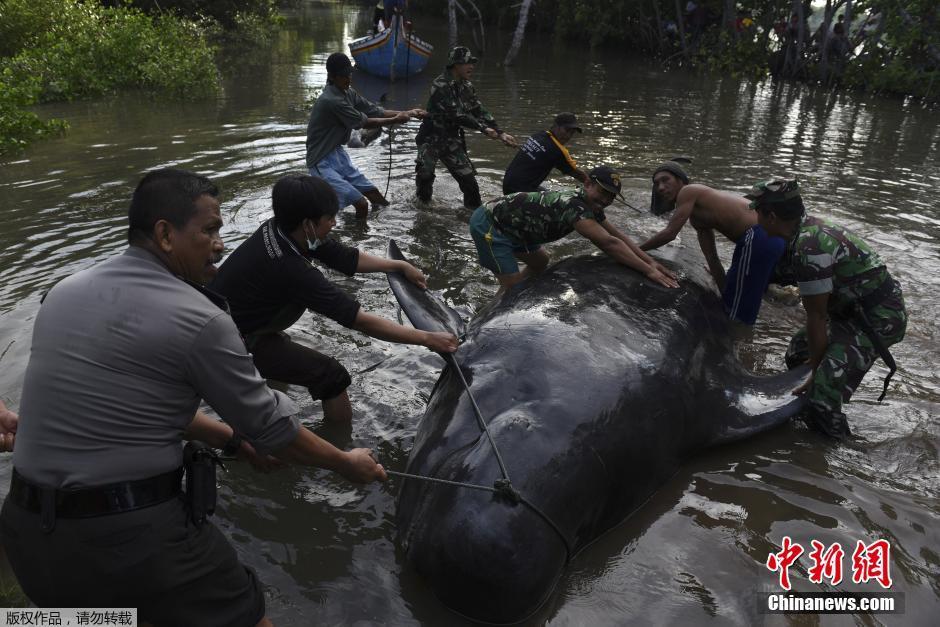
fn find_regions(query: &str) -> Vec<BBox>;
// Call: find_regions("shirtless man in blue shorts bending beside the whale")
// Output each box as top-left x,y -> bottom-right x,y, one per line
640,161 -> 786,325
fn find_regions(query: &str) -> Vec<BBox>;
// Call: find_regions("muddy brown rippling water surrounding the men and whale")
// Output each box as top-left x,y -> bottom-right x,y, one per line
0,3 -> 940,625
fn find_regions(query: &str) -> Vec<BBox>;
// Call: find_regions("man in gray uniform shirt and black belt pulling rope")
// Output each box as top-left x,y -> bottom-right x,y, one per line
0,170 -> 385,627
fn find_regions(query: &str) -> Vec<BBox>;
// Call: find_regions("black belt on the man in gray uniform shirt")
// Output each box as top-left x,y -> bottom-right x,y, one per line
9,467 -> 183,532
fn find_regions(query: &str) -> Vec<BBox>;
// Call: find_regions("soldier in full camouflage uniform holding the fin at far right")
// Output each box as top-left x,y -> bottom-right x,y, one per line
748,180 -> 907,439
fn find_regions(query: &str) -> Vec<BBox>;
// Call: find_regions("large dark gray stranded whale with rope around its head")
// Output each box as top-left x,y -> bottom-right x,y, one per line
390,243 -> 807,624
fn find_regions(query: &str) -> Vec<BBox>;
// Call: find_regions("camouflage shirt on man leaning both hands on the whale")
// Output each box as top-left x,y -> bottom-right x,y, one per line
483,189 -> 607,246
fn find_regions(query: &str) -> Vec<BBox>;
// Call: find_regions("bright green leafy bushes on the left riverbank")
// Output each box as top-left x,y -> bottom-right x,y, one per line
0,0 -> 277,155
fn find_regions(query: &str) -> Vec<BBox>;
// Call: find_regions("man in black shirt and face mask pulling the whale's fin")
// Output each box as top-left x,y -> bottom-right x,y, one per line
211,175 -> 457,423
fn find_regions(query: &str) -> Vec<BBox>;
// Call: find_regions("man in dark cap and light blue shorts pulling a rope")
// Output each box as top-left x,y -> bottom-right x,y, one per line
307,52 -> 427,220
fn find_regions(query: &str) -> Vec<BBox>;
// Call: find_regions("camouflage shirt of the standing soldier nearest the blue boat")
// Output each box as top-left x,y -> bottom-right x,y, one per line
417,70 -> 499,144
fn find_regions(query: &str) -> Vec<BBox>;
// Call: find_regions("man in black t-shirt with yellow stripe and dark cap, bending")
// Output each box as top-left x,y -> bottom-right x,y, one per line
503,113 -> 587,194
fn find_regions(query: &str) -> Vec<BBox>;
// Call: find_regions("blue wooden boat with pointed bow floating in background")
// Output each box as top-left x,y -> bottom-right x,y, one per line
349,15 -> 434,80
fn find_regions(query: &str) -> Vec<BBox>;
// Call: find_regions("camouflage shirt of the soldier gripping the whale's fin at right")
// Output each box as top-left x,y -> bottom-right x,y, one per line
787,216 -> 888,311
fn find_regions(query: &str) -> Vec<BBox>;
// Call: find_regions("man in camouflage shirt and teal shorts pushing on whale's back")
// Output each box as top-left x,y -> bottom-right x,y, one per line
470,165 -> 679,293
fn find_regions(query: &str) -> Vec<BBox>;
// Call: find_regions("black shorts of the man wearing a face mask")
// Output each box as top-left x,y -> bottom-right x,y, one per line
248,332 -> 352,400
